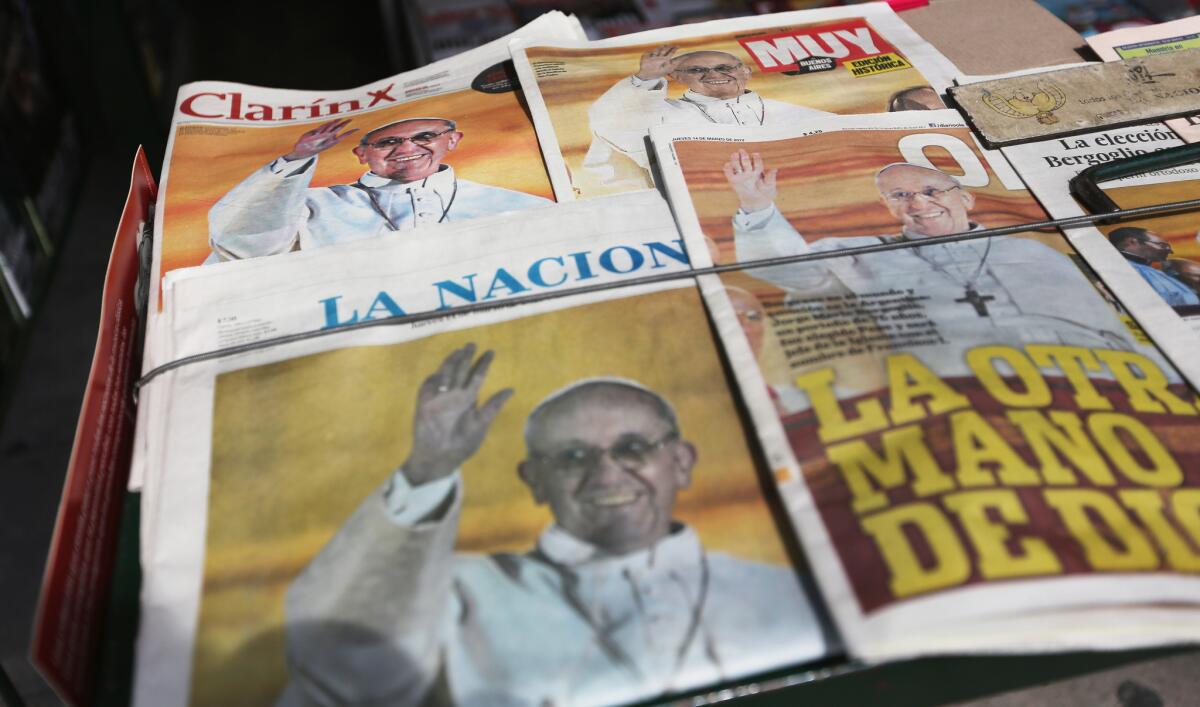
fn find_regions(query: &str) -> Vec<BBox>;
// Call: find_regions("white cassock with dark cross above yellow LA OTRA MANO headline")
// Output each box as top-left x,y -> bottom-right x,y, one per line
733,206 -> 1142,376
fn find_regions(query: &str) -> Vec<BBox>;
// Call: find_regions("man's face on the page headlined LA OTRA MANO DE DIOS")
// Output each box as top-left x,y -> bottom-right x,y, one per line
878,167 -> 974,236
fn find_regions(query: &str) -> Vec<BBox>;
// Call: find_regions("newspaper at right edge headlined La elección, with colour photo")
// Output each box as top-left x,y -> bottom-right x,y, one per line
1003,122 -> 1200,336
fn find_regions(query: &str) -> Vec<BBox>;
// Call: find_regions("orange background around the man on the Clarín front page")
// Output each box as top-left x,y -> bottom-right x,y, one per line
161,85 -> 553,275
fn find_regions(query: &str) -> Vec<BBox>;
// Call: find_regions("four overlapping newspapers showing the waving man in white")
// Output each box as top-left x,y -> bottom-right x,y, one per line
124,4 -> 1200,706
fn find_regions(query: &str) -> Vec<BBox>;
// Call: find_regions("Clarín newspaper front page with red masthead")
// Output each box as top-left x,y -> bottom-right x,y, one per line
146,12 -> 582,374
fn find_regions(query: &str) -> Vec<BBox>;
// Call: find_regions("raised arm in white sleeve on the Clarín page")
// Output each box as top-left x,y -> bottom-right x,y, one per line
209,119 -> 356,260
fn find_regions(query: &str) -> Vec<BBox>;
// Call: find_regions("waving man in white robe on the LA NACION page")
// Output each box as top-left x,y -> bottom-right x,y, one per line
281,344 -> 827,707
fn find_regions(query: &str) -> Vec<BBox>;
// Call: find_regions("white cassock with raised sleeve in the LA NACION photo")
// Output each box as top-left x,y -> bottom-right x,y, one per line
280,472 -> 827,707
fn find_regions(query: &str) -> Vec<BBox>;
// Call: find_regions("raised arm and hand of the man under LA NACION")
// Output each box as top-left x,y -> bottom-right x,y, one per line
283,343 -> 512,705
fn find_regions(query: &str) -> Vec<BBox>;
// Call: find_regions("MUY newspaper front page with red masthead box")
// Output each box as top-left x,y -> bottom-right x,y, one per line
512,2 -> 956,202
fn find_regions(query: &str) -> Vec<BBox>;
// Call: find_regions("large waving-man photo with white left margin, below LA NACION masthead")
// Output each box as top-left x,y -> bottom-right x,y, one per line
134,280 -> 836,707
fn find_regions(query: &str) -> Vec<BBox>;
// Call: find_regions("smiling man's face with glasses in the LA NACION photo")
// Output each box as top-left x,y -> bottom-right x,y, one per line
518,385 -> 696,555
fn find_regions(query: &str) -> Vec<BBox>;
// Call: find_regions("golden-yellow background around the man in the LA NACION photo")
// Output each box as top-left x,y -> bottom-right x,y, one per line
192,288 -> 790,706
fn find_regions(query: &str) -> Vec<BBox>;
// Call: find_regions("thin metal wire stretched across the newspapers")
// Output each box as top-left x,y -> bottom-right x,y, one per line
134,199 -> 1200,394
